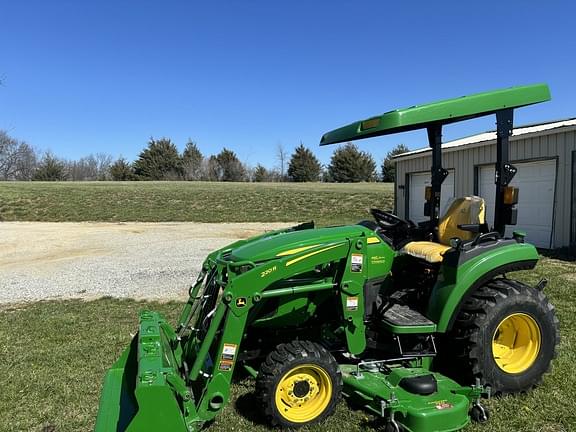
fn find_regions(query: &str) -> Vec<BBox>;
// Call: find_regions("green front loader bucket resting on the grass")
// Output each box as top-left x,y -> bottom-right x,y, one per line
94,311 -> 196,432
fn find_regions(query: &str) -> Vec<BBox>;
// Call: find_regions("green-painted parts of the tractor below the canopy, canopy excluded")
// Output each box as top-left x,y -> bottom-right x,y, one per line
96,216 -> 537,432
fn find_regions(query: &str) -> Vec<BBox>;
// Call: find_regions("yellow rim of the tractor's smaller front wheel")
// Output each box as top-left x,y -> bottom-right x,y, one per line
275,364 -> 332,423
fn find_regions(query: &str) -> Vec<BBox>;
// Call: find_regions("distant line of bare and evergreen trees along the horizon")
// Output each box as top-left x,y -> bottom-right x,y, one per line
0,130 -> 408,183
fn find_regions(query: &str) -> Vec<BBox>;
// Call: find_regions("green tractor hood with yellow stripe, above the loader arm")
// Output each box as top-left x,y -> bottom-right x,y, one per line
231,225 -> 373,262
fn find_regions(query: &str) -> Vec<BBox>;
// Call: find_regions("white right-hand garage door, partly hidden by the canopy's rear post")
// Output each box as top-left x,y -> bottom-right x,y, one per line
478,160 -> 556,248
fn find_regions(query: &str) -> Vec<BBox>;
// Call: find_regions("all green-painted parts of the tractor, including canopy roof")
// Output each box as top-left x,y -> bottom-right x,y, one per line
95,85 -> 550,432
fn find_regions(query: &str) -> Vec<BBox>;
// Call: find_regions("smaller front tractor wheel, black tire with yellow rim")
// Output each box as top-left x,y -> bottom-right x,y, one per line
256,341 -> 342,428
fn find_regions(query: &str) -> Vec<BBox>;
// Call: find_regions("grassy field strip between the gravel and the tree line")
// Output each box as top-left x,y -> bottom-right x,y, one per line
0,182 -> 394,225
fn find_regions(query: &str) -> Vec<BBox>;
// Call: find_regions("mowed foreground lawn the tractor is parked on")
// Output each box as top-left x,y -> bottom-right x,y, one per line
0,258 -> 576,432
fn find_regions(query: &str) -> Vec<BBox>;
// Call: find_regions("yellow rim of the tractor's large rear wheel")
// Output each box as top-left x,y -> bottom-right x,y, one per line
492,313 -> 542,374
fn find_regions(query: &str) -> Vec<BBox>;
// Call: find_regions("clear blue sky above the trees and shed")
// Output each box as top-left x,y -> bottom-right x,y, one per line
0,0 -> 576,167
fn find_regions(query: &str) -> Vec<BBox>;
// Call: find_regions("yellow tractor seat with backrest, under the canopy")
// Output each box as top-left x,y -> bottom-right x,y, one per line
401,196 -> 485,263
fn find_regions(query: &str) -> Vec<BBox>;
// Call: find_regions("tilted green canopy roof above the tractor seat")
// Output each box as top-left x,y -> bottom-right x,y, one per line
320,84 -> 550,145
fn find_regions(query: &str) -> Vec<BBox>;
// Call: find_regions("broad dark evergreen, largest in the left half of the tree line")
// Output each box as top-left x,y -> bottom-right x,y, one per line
134,138 -> 182,180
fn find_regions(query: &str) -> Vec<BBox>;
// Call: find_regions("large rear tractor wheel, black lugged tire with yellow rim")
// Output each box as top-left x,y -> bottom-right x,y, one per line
449,279 -> 560,394
